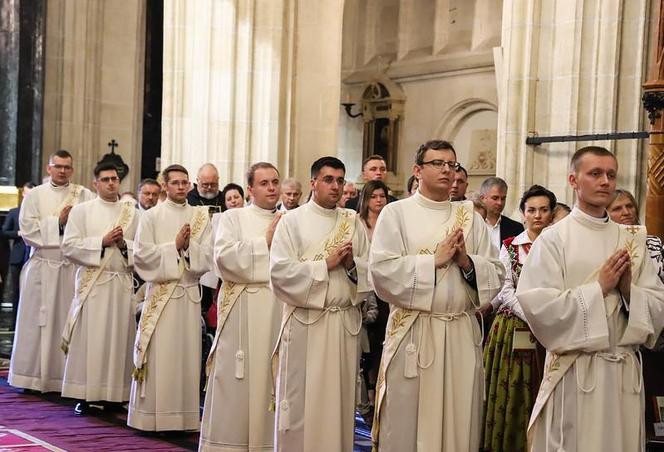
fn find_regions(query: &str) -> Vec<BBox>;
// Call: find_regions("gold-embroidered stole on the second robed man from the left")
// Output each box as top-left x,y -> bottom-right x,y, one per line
60,202 -> 136,355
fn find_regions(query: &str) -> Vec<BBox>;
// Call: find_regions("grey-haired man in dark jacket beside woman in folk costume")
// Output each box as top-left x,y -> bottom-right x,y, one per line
480,177 -> 523,251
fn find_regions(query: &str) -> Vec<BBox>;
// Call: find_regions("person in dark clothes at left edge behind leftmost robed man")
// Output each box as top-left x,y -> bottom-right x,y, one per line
2,182 -> 34,327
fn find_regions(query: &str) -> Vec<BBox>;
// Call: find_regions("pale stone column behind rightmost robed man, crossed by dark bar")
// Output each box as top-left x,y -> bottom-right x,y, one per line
496,0 -> 649,209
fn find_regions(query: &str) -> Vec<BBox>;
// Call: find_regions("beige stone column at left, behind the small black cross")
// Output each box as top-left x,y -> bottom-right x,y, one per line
43,0 -> 145,190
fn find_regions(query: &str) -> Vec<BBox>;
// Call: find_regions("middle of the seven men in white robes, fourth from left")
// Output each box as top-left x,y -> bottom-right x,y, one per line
199,162 -> 282,452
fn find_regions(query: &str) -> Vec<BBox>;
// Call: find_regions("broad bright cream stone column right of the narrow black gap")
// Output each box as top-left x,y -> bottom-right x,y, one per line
162,0 -> 343,184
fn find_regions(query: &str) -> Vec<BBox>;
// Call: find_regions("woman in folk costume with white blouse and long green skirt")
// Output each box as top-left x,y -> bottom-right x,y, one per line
483,185 -> 556,452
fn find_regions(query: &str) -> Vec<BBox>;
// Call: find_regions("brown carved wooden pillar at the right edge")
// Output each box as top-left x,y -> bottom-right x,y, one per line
641,0 -> 664,238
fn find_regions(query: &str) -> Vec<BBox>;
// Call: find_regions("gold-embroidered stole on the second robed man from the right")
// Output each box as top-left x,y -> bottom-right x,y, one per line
371,201 -> 474,451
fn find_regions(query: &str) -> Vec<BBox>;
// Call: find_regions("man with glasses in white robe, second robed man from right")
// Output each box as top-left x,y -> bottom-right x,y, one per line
370,140 -> 504,452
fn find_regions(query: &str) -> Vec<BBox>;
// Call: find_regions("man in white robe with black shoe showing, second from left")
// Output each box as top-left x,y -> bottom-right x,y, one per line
62,163 -> 138,415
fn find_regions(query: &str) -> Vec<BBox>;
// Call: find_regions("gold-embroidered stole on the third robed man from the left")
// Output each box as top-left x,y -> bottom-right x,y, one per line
132,206 -> 210,383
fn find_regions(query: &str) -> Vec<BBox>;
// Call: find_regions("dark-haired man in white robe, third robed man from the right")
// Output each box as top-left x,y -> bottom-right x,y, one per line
270,157 -> 370,452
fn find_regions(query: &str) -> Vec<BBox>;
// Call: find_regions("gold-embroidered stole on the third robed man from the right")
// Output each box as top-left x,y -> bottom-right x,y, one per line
270,208 -> 357,410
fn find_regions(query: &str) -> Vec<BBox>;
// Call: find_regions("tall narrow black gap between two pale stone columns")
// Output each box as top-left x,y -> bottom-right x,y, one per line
141,0 -> 164,179
